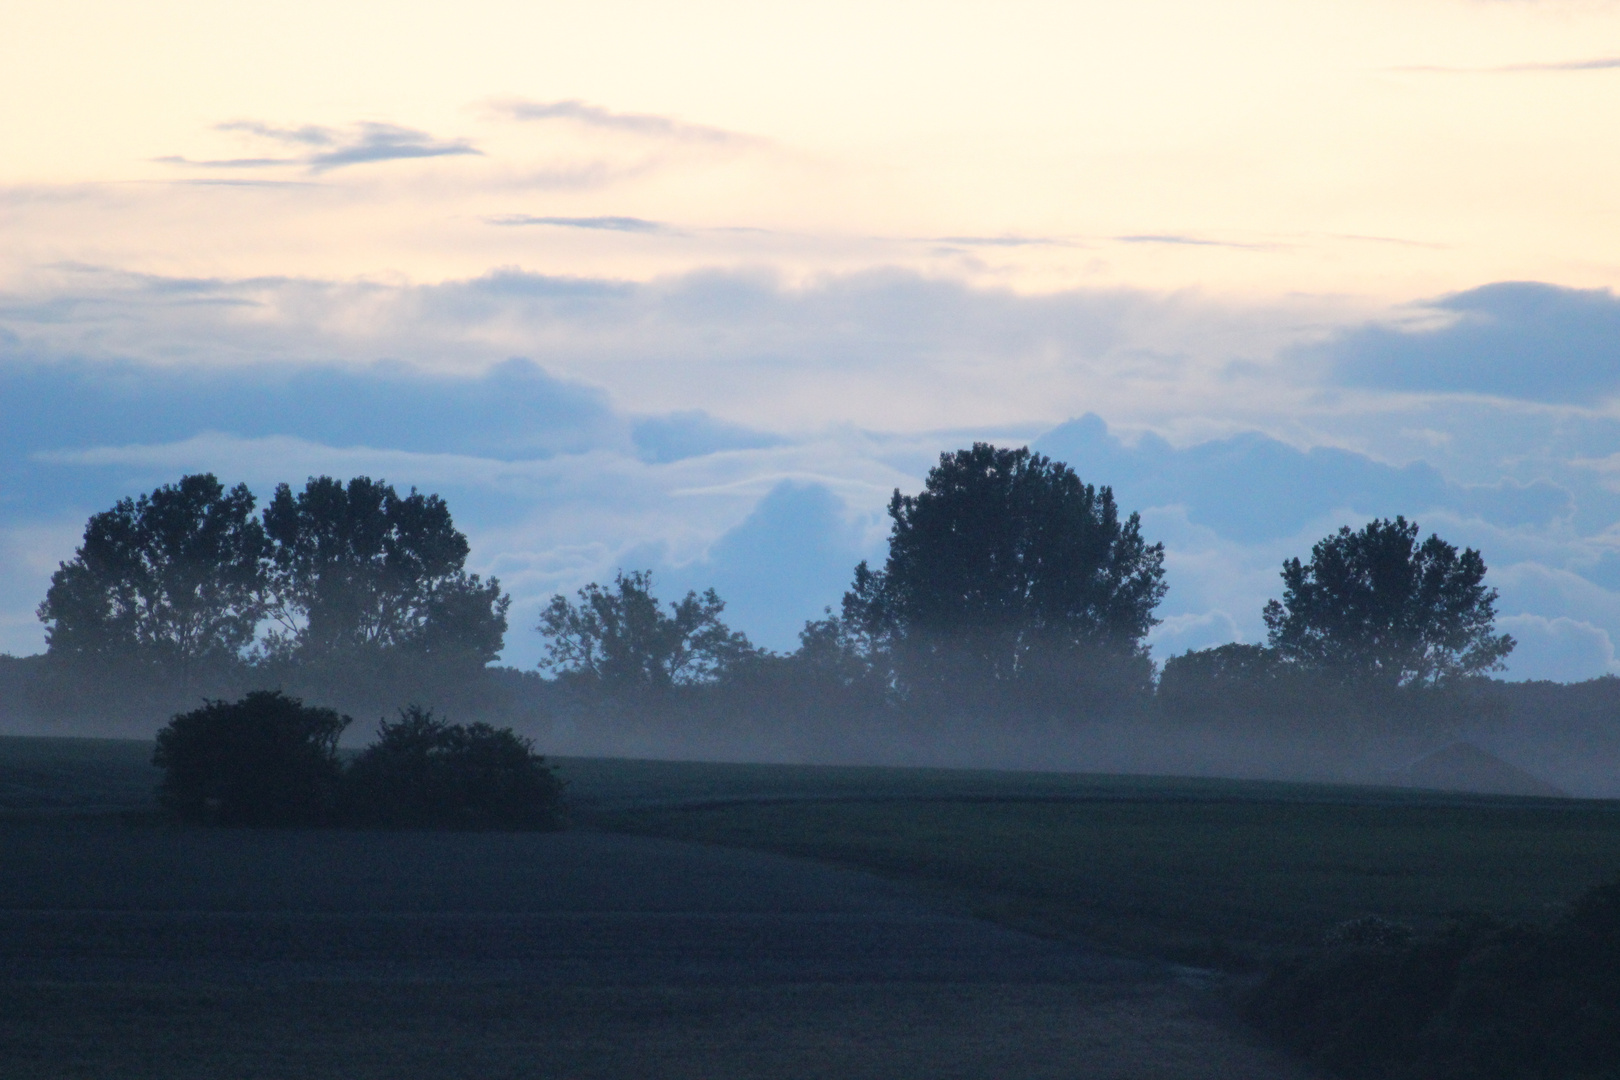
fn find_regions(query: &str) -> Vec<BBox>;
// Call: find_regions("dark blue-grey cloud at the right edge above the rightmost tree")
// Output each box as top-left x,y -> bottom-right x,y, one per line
1307,282 -> 1620,405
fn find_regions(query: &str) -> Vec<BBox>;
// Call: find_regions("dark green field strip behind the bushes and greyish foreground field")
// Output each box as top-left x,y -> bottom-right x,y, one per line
9,738 -> 1620,968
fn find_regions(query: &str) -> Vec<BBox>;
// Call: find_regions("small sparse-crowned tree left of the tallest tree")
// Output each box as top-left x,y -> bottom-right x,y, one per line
536,570 -> 755,693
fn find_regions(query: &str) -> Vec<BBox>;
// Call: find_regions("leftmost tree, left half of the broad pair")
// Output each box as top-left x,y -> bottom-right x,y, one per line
39,473 -> 267,685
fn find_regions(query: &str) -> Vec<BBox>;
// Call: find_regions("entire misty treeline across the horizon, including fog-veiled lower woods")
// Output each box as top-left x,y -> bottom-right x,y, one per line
0,444 -> 1617,771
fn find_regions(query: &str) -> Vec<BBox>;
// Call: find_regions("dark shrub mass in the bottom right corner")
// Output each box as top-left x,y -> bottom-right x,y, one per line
1249,881 -> 1620,1080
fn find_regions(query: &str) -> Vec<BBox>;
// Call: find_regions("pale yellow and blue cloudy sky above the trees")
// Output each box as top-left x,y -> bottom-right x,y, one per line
0,0 -> 1620,680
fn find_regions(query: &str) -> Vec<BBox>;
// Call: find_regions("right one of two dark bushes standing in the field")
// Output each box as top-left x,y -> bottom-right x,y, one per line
343,706 -> 564,829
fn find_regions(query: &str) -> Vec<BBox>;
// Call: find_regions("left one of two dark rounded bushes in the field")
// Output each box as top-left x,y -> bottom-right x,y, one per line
152,690 -> 350,826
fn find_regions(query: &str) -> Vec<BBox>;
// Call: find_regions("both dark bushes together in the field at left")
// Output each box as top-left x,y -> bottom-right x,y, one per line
152,690 -> 564,829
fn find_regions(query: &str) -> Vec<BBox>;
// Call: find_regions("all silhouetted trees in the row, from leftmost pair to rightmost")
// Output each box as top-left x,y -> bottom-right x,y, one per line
28,444 -> 1513,738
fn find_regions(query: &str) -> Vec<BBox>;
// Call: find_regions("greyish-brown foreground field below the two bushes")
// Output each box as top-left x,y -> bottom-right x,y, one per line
0,823 -> 1299,1080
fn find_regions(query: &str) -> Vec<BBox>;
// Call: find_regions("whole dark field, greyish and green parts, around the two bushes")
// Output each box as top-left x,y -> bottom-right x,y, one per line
0,740 -> 1620,1077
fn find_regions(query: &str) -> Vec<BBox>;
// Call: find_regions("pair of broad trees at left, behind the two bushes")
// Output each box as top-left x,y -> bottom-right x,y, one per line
39,474 -> 510,712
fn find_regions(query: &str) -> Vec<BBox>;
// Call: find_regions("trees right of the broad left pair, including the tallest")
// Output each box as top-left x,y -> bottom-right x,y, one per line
539,444 -> 1513,731
